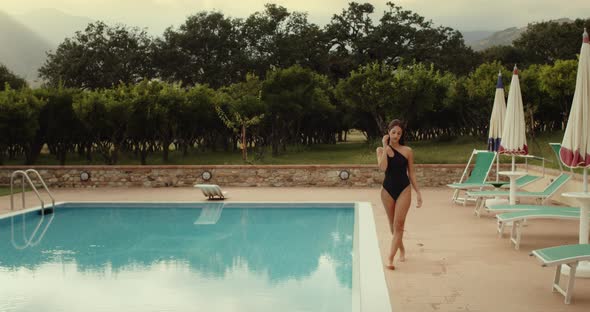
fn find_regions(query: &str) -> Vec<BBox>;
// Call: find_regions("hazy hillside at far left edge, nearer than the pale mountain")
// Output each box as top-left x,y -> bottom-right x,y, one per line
0,11 -> 54,85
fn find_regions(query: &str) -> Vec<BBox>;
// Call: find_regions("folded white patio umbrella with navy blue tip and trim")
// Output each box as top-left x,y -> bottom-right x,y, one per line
488,71 -> 506,181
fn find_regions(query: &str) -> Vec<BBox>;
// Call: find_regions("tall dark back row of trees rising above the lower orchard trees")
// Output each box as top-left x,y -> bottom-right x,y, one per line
39,2 -> 479,89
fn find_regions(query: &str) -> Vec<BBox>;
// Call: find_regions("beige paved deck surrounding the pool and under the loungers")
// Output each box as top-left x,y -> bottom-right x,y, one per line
0,187 -> 590,312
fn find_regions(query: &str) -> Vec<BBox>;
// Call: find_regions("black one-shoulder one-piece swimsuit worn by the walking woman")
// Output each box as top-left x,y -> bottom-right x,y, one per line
383,147 -> 410,200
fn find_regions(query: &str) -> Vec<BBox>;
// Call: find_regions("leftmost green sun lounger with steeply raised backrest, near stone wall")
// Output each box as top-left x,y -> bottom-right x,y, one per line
447,149 -> 496,205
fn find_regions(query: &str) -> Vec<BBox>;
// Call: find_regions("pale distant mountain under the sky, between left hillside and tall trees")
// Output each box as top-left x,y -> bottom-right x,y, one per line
15,9 -> 94,47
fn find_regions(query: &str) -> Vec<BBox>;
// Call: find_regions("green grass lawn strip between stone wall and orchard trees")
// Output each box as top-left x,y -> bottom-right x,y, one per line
0,132 -> 563,168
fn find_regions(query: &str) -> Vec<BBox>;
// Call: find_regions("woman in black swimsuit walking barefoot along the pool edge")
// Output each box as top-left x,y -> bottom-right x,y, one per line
377,119 -> 422,270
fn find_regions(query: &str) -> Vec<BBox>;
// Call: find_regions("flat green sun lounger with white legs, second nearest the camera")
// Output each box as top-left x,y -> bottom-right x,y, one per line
496,208 -> 580,249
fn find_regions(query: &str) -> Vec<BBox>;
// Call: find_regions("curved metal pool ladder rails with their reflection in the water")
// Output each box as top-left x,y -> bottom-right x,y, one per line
10,169 -> 55,249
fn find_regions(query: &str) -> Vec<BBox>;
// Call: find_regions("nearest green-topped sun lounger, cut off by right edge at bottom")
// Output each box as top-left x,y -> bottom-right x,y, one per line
531,244 -> 590,304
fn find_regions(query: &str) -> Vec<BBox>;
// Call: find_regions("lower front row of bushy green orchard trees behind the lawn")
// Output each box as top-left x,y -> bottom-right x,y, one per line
0,60 -> 577,164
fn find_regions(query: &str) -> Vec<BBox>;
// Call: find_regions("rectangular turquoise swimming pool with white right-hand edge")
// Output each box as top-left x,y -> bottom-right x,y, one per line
0,202 -> 390,312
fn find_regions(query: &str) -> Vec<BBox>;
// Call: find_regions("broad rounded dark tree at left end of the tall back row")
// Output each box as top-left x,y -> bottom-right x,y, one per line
39,21 -> 153,89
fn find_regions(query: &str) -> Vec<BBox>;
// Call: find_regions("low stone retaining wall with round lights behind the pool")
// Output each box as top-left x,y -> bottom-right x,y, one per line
0,164 -> 508,188
